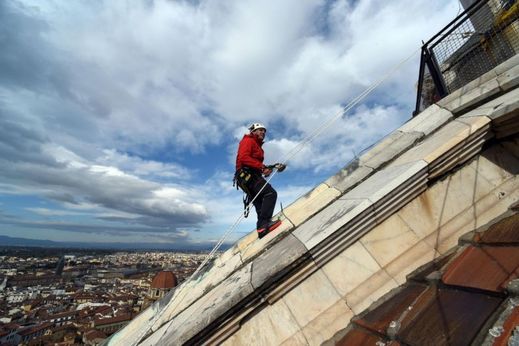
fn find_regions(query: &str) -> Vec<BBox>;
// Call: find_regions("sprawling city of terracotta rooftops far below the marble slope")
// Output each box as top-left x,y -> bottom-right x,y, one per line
0,247 -> 202,345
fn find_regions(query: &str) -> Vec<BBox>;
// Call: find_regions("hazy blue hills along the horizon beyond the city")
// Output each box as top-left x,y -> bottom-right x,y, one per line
0,235 -> 222,251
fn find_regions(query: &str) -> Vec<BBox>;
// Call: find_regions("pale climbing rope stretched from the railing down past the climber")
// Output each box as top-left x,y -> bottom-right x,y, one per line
130,49 -> 420,346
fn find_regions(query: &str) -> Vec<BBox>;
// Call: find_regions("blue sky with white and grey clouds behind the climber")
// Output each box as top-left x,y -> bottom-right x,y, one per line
0,0 -> 460,247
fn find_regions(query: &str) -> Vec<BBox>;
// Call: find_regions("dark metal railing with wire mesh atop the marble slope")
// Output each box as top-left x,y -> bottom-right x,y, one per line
413,0 -> 519,115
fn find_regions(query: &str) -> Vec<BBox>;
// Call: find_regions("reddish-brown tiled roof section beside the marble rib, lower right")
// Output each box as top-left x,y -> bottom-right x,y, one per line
335,212 -> 519,345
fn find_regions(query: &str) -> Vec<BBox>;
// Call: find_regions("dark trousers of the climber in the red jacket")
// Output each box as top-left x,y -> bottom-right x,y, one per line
248,175 -> 278,229
